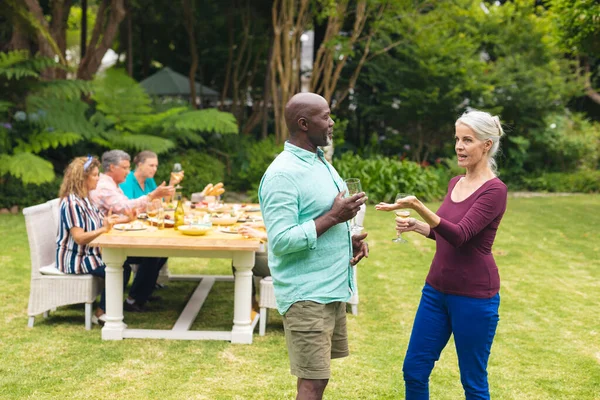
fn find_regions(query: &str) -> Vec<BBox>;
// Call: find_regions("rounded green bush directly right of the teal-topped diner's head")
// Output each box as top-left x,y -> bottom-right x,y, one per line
155,150 -> 230,197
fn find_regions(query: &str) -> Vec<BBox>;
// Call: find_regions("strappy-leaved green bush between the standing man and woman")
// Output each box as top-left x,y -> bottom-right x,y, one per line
333,152 -> 447,203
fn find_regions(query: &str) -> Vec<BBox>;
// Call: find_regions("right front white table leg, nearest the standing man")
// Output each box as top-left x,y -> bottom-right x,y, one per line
231,251 -> 254,344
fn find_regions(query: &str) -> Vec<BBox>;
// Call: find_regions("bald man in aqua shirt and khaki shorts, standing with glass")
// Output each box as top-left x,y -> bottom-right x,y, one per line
259,93 -> 368,400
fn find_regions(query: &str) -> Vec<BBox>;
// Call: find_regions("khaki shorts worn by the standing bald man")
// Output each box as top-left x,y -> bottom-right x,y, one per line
283,301 -> 349,379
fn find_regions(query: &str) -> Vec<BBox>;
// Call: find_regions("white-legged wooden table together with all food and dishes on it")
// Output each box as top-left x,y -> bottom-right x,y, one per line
90,179 -> 265,344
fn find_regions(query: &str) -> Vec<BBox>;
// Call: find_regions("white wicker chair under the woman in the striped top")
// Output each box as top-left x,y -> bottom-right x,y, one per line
23,199 -> 104,330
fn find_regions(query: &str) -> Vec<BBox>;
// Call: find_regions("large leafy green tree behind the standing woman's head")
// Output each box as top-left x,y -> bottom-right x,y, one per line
338,0 -> 576,176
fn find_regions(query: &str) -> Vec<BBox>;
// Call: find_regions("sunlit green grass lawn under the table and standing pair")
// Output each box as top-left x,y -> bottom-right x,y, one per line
0,195 -> 600,400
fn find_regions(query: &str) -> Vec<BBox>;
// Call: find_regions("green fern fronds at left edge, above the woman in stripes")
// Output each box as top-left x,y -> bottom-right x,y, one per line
0,51 -> 90,184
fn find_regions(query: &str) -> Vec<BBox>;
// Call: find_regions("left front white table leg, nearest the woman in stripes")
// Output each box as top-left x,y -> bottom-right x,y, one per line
102,248 -> 127,340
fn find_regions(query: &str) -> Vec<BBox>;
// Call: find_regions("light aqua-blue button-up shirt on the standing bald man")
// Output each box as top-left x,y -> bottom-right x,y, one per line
258,142 -> 354,314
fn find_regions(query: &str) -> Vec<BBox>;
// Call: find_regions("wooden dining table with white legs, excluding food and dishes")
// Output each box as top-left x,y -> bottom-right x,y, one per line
90,222 -> 264,344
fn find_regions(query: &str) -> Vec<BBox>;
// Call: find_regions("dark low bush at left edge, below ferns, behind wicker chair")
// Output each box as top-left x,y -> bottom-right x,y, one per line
0,176 -> 62,208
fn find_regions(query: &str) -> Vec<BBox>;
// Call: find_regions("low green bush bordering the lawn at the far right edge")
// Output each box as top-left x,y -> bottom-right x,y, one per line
523,170 -> 600,193
